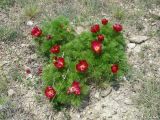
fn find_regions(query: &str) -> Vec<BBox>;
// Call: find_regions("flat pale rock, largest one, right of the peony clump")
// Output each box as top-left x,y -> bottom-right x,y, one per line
129,36 -> 148,44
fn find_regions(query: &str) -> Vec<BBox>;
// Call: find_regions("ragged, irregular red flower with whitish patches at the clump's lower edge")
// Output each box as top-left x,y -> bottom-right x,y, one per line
67,81 -> 81,95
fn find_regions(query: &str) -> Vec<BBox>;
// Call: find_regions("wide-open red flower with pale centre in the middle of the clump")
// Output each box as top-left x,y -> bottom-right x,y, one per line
76,60 -> 88,72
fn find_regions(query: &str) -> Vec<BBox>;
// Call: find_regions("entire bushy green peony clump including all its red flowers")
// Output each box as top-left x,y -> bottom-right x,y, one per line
32,17 -> 127,108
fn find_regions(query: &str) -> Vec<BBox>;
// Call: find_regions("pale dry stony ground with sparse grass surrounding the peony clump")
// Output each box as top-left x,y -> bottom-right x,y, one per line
0,0 -> 160,120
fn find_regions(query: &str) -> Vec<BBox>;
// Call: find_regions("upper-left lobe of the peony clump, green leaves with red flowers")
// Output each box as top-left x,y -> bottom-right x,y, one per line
31,17 -> 75,57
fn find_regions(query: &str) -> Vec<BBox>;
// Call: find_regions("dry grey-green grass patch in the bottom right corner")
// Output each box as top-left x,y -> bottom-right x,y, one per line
136,79 -> 160,120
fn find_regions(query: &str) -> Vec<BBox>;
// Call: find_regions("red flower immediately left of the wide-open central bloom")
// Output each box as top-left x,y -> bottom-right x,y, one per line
53,57 -> 65,69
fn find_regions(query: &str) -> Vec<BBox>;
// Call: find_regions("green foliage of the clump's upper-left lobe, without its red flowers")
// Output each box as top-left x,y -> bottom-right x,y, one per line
35,17 -> 75,56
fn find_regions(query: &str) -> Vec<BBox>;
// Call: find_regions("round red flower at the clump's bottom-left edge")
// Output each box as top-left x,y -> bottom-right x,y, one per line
45,86 -> 56,100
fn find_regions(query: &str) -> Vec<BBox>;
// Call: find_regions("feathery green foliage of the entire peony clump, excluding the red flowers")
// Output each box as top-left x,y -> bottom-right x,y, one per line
32,17 -> 128,108
